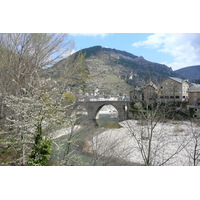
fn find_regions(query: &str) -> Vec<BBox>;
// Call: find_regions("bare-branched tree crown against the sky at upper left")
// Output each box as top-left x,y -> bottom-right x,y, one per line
0,33 -> 73,95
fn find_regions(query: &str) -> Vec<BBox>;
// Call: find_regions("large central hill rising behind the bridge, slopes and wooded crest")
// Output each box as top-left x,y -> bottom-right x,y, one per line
46,46 -> 175,94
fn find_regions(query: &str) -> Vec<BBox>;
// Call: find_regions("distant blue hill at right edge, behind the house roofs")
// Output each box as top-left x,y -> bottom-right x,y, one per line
174,65 -> 200,82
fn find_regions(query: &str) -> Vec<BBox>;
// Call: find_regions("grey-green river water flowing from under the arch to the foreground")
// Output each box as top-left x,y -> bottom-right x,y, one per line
52,113 -> 121,166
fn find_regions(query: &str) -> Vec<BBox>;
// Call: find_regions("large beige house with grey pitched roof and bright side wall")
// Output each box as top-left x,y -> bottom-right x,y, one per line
158,77 -> 189,102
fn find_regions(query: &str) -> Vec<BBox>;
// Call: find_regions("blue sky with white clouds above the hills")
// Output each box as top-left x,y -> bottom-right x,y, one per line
71,33 -> 200,70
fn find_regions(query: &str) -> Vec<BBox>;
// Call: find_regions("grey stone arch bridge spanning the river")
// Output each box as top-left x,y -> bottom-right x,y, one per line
76,101 -> 130,121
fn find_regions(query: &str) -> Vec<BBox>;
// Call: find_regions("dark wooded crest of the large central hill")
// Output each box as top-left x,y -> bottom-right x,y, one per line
73,46 -> 174,82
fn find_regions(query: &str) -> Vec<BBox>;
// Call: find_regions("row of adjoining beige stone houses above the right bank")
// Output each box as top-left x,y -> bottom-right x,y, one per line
130,77 -> 200,118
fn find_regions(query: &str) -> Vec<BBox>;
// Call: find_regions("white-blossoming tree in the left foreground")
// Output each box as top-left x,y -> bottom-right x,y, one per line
4,80 -> 77,165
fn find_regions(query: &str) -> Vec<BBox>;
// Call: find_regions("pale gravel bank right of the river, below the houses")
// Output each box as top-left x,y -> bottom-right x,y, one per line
91,120 -> 200,166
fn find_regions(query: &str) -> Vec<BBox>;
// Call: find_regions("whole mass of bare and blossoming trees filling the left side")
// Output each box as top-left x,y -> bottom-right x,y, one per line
0,33 -> 76,165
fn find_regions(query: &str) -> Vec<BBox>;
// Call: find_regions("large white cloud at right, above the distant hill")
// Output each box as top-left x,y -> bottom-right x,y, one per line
132,33 -> 200,70
